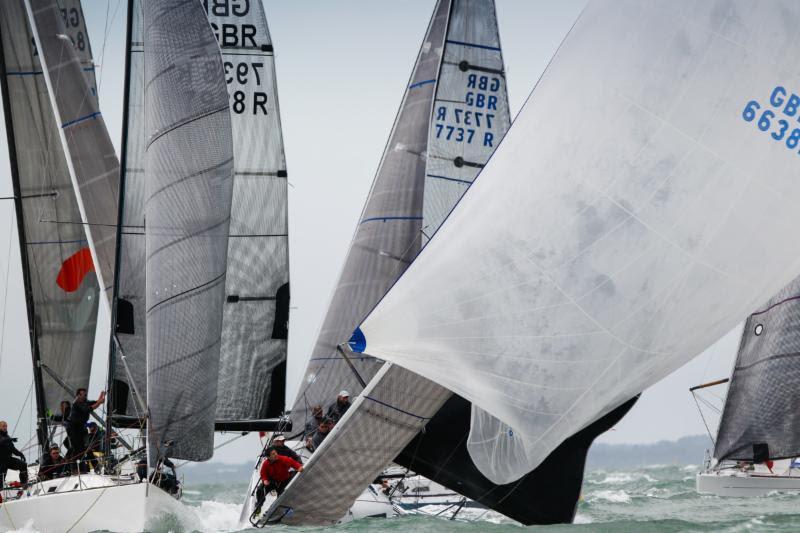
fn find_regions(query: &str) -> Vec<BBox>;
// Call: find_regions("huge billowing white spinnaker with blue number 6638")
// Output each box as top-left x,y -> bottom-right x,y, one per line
361,0 -> 800,479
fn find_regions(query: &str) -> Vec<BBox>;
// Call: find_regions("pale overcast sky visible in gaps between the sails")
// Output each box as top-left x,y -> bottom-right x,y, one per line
0,0 -> 739,463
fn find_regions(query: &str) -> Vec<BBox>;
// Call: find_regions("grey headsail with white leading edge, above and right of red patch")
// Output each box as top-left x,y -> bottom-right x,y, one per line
25,0 -> 119,298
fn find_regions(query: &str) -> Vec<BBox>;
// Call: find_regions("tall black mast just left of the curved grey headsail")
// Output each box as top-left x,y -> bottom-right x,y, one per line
104,0 -> 133,453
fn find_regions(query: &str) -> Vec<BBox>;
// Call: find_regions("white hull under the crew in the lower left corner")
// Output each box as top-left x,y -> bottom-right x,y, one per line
0,474 -> 181,533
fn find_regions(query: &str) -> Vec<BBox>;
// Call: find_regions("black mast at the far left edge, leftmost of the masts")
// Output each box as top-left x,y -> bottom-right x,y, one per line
0,20 -> 48,450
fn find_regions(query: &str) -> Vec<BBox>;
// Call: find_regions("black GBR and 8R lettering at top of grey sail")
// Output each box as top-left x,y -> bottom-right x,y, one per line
203,0 -> 272,115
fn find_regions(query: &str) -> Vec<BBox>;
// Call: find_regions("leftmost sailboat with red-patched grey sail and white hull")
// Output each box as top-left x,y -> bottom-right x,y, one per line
0,0 -> 180,531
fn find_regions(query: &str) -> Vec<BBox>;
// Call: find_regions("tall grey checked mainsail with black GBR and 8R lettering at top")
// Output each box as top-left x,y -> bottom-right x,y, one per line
206,2 -> 289,421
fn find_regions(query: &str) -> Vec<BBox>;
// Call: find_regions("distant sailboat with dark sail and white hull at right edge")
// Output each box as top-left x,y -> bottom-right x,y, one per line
693,279 -> 800,496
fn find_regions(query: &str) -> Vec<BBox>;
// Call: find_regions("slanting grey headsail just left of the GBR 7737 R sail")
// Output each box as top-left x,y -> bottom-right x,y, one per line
292,1 -> 450,428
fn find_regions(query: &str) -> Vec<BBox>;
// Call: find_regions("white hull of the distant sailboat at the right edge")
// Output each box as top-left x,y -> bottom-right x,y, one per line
697,470 -> 800,497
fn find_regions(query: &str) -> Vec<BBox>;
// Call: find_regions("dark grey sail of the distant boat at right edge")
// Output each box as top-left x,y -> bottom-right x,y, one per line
714,278 -> 800,462
